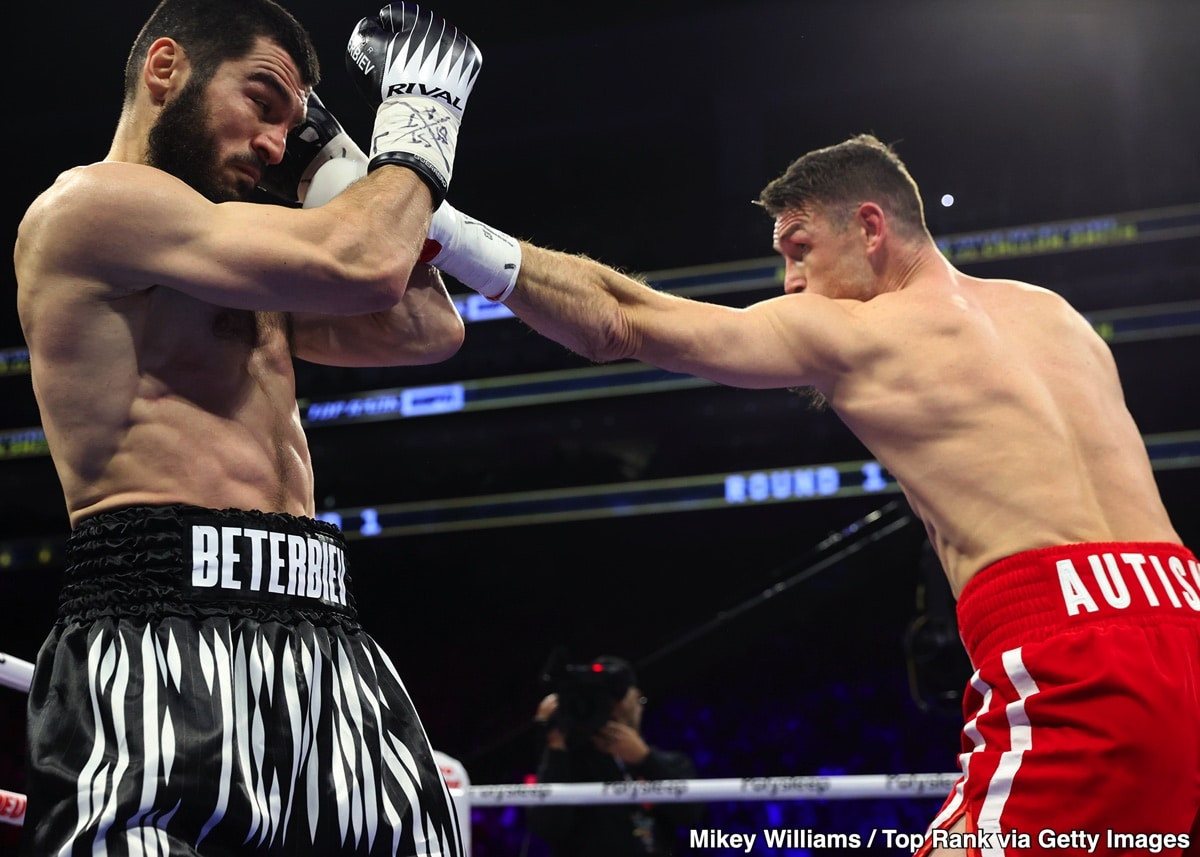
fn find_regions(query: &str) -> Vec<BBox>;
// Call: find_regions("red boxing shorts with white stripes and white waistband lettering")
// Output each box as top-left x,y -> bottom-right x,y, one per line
920,543 -> 1200,857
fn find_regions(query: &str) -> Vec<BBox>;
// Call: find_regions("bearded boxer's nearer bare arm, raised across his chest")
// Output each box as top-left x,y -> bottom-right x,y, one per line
18,162 -> 430,314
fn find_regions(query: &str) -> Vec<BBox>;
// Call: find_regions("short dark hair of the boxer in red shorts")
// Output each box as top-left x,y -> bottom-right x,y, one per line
758,134 -> 928,234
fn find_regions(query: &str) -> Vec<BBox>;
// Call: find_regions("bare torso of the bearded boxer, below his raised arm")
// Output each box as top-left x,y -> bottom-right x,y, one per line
18,253 -> 313,525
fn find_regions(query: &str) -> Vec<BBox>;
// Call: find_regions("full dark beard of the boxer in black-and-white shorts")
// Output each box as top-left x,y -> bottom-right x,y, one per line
146,76 -> 248,203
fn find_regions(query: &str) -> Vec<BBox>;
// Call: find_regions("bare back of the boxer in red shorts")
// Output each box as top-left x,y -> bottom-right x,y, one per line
830,272 -> 1178,594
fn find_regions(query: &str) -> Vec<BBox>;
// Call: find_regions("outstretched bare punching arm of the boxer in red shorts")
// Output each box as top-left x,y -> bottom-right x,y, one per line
505,244 -> 864,389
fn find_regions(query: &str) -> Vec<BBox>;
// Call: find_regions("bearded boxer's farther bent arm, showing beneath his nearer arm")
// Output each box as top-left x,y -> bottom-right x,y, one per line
293,264 -> 464,366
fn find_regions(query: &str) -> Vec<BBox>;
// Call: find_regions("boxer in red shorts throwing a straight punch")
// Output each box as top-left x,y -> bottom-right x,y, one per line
410,133 -> 1200,855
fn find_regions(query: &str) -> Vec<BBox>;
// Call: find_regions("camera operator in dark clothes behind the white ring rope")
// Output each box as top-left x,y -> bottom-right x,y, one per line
527,655 -> 702,857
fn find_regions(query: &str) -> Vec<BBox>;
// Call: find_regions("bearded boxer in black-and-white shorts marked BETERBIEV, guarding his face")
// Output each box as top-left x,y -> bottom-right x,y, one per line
13,0 -> 480,857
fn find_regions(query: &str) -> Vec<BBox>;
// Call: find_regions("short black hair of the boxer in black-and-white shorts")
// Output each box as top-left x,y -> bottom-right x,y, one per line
125,0 -> 320,103
